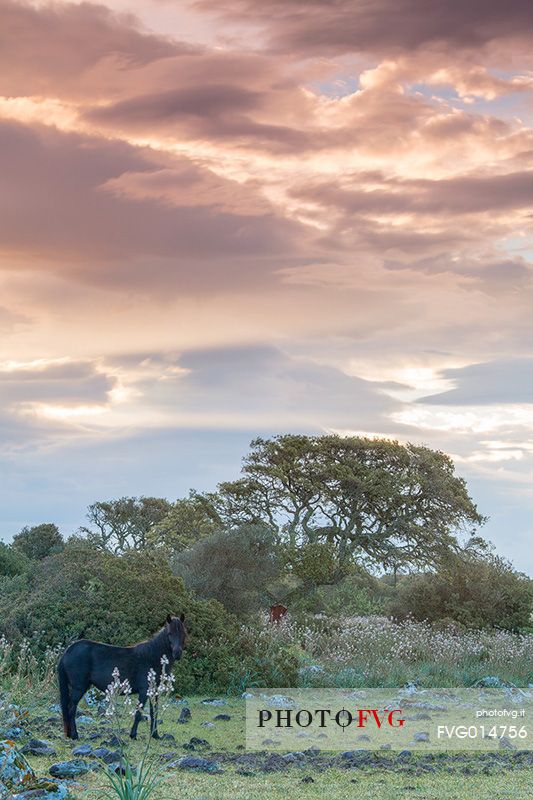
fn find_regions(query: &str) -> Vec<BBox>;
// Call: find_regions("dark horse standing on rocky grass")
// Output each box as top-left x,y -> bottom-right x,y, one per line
57,614 -> 187,739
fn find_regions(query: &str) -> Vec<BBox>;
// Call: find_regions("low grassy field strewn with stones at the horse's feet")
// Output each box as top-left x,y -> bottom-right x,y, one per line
9,698 -> 533,800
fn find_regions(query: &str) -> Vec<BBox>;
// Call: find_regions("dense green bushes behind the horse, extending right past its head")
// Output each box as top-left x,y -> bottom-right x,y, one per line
0,539 -> 298,694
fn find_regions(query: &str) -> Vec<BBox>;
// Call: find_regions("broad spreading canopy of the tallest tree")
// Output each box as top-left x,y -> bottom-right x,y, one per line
209,435 -> 484,574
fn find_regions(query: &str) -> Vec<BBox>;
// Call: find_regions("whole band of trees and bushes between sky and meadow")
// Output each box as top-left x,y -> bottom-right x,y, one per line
0,436 -> 533,692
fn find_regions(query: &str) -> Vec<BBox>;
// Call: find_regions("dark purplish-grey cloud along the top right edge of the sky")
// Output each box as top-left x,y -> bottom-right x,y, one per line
193,0 -> 533,56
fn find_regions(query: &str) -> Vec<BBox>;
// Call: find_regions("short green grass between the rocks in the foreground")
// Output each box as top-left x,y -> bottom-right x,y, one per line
8,697 -> 533,800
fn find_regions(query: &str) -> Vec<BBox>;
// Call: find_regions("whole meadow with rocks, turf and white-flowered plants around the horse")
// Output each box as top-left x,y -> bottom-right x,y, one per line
0,615 -> 533,800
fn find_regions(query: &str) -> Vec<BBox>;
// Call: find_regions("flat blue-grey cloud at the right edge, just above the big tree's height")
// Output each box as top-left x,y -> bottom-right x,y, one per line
418,358 -> 533,406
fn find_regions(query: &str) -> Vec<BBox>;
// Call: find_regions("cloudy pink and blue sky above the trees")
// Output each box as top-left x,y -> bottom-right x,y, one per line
0,0 -> 533,574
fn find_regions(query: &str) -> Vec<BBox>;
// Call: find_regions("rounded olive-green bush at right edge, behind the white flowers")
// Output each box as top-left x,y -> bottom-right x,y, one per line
390,553 -> 533,631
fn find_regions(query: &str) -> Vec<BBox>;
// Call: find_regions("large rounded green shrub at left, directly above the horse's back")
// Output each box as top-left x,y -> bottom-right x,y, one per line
0,539 -> 216,650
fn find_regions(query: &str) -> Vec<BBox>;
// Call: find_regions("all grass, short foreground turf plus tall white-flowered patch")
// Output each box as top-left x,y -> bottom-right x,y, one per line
4,617 -> 533,800
